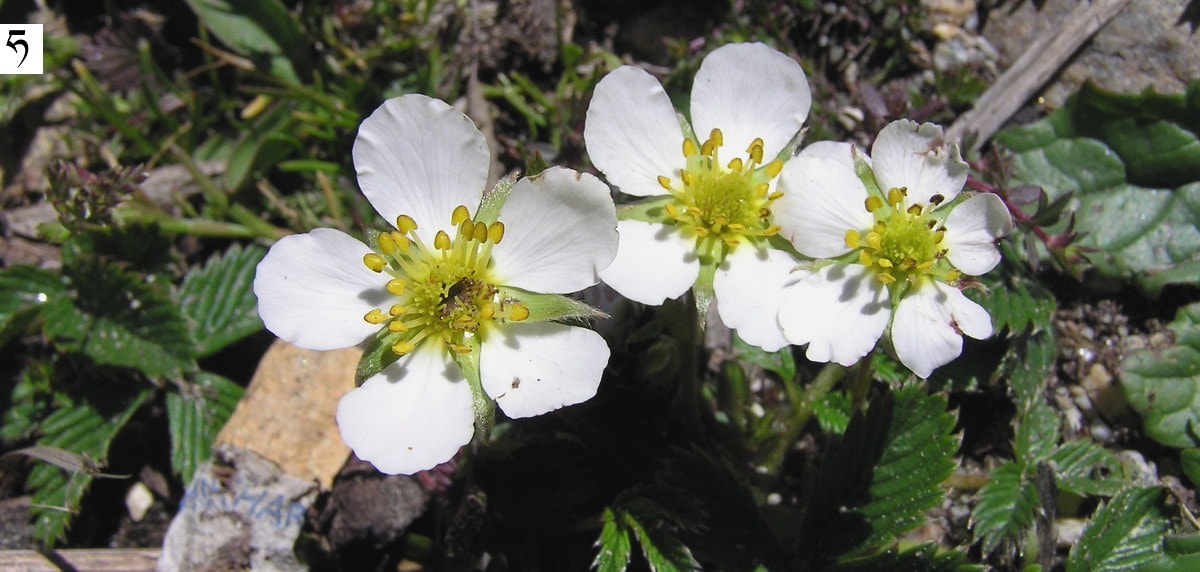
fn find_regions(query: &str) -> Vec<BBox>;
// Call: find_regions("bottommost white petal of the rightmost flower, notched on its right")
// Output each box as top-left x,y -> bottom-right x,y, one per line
892,282 -> 991,378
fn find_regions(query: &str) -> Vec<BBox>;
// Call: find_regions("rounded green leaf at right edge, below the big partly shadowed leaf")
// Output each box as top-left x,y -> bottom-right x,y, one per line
1121,300 -> 1200,448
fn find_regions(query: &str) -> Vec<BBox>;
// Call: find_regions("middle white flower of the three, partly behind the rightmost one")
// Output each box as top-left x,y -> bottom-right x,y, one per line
583,43 -> 812,351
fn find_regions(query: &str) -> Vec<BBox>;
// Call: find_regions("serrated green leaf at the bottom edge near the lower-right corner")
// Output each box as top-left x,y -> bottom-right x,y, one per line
1067,487 -> 1170,572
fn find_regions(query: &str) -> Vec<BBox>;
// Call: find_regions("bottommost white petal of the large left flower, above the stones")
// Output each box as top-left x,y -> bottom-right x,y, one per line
337,344 -> 475,475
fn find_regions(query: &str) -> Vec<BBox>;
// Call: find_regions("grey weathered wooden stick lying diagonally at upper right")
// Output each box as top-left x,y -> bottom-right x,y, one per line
946,0 -> 1129,151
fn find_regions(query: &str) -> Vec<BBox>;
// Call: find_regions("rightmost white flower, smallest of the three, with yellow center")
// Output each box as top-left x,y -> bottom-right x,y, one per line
775,120 -> 1013,378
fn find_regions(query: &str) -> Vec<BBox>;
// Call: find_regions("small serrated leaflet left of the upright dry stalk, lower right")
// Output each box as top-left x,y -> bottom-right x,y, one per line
971,463 -> 1038,553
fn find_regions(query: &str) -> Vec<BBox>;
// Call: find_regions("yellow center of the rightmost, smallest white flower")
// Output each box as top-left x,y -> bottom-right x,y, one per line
846,188 -> 960,284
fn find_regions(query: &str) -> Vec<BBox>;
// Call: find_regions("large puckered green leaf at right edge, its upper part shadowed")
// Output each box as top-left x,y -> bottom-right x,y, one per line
997,82 -> 1200,294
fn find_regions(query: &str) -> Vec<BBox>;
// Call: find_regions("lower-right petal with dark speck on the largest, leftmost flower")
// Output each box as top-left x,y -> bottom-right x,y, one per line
479,321 -> 608,419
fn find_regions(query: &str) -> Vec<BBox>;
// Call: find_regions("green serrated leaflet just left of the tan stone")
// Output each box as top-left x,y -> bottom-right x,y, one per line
167,372 -> 245,484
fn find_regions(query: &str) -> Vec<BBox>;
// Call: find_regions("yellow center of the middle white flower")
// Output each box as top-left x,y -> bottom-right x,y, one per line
659,130 -> 784,259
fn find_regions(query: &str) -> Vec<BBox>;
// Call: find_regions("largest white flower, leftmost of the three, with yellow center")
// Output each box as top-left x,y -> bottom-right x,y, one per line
254,95 -> 617,474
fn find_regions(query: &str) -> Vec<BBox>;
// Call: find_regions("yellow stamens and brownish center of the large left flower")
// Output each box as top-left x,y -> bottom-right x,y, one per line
362,205 -> 529,355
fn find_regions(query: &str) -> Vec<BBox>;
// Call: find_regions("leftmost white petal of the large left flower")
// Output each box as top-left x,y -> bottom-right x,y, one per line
254,228 -> 390,350
